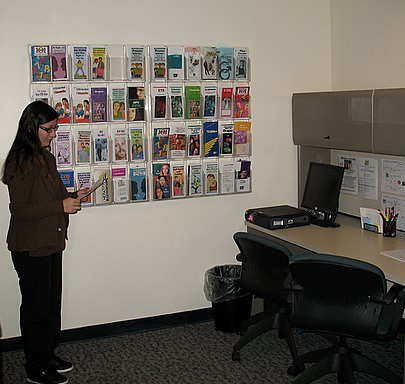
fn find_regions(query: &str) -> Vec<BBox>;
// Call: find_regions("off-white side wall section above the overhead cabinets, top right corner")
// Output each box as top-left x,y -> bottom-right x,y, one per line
331,0 -> 405,90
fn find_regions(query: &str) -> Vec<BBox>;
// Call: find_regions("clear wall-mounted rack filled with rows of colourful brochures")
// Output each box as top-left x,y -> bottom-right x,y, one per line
29,44 -> 252,205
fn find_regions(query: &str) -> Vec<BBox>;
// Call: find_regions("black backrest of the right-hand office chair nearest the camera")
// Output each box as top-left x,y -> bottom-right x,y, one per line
290,255 -> 385,337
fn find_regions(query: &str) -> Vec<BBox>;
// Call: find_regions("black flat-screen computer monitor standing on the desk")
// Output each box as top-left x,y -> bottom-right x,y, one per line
301,162 -> 344,227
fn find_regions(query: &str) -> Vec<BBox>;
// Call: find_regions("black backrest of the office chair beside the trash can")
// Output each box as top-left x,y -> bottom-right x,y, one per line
234,233 -> 289,303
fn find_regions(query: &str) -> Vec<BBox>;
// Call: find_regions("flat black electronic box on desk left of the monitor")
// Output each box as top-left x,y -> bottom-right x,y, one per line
245,205 -> 311,229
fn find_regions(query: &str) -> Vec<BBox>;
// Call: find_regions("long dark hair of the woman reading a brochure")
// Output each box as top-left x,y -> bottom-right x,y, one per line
2,101 -> 58,184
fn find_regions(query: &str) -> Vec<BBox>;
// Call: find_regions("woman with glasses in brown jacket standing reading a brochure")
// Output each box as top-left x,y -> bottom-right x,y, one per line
2,101 -> 85,384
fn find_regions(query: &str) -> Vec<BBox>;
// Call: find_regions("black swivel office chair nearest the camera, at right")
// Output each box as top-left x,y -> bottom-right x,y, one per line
289,254 -> 405,384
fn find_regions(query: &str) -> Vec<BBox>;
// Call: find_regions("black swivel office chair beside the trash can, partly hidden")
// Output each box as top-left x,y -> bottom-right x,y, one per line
232,232 -> 303,373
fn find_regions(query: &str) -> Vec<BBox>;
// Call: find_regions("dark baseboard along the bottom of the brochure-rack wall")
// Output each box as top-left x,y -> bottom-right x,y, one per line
0,308 -> 213,352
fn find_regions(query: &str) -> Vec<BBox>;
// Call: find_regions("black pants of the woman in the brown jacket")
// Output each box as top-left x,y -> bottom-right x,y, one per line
11,252 -> 62,372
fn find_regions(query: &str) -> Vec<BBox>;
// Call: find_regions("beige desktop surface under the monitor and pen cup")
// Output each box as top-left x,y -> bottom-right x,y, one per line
245,215 -> 405,286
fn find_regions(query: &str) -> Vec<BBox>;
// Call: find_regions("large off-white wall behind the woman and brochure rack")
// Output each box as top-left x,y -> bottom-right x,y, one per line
0,0 -> 331,337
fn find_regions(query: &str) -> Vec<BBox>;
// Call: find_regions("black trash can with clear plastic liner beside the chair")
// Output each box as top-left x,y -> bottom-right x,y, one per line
204,265 -> 252,333
